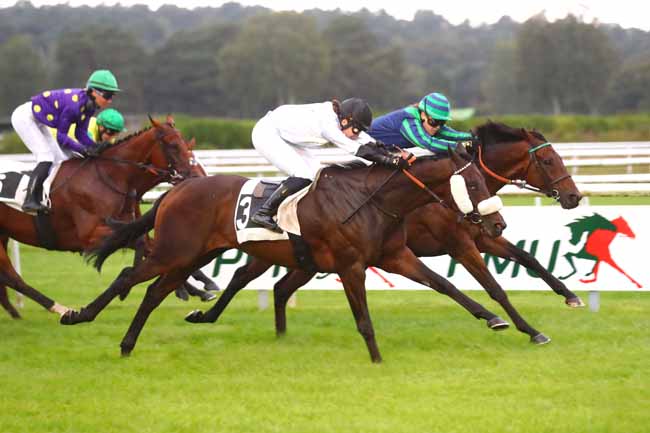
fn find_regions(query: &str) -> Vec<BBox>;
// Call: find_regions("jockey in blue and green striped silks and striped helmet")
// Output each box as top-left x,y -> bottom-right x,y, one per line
368,93 -> 476,154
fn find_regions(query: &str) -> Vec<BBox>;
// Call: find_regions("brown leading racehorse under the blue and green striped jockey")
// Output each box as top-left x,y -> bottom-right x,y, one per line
188,122 -> 584,344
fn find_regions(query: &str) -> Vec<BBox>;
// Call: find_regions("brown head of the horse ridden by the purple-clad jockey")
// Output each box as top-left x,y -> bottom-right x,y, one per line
149,115 -> 194,183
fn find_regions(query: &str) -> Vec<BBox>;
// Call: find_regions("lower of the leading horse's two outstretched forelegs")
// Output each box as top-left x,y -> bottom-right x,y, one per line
453,248 -> 551,344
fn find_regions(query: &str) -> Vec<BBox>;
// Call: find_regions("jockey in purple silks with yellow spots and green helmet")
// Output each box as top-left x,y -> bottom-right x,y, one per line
11,70 -> 120,212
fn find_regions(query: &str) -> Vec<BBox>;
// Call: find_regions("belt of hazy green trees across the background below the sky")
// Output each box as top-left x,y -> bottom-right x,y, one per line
0,1 -> 650,120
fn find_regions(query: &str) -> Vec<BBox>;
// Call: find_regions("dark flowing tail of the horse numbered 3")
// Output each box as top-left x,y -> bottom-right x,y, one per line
84,193 -> 167,271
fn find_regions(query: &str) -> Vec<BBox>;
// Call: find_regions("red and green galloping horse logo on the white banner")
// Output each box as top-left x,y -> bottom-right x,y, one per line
561,213 -> 642,289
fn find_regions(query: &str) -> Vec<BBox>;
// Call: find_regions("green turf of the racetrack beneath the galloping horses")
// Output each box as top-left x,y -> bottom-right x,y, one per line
0,247 -> 650,433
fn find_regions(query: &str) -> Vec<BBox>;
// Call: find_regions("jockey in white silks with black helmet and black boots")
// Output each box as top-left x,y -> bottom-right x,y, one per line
251,98 -> 408,232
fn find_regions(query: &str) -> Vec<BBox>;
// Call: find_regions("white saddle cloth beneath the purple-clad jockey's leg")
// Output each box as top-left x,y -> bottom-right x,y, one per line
0,161 -> 61,211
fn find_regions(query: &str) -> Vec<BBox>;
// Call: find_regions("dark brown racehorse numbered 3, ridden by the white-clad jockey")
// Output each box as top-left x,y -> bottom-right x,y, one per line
61,146 -> 505,362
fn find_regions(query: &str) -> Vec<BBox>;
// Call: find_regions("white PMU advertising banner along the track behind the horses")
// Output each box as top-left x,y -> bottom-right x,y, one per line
203,206 -> 650,291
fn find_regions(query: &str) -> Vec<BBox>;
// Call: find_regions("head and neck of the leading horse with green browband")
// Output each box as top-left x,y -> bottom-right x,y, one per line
468,122 -> 582,209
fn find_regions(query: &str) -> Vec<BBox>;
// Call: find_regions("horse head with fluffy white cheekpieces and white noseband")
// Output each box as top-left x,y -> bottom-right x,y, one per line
448,146 -> 506,237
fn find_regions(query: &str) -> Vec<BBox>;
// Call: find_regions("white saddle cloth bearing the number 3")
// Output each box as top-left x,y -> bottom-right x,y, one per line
234,179 -> 309,244
